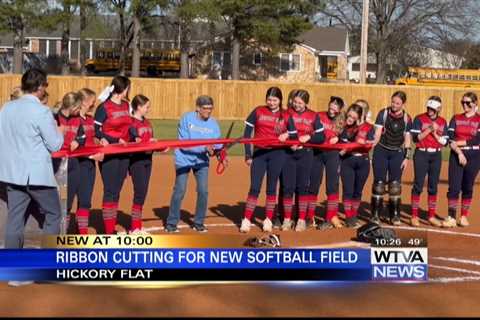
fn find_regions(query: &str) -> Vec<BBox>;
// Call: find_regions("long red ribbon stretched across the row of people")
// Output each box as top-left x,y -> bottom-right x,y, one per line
52,138 -> 372,159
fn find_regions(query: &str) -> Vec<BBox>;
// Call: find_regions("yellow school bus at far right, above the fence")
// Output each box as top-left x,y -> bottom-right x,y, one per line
395,67 -> 480,88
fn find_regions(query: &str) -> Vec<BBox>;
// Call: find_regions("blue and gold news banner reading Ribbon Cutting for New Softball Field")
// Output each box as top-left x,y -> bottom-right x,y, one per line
0,235 -> 428,282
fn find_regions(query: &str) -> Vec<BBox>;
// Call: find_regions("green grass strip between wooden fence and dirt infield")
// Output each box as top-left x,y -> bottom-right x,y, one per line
151,120 -> 450,161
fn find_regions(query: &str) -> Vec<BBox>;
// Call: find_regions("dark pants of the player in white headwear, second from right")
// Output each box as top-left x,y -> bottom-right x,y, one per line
412,149 -> 442,196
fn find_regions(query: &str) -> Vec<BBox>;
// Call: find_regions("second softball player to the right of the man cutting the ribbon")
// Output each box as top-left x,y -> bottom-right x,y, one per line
282,90 -> 325,231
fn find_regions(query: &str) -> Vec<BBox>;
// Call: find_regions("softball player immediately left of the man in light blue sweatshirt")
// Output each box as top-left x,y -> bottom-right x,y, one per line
128,94 -> 154,234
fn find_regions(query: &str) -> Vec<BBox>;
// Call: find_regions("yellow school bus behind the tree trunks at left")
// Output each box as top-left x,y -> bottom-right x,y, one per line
85,48 -> 180,76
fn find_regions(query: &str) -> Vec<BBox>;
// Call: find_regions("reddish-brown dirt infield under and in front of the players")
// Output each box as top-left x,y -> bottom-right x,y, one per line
0,156 -> 480,316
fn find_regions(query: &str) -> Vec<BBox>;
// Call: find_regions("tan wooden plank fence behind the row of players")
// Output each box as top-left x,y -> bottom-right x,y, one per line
0,75 -> 478,119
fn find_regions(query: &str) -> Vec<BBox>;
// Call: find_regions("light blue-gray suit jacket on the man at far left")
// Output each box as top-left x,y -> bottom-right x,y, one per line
0,94 -> 63,187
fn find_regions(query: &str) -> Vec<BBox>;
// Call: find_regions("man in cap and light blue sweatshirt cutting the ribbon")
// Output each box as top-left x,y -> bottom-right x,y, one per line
165,96 -> 222,233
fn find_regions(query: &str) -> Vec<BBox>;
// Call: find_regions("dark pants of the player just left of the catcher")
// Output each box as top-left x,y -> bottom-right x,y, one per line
340,155 -> 370,200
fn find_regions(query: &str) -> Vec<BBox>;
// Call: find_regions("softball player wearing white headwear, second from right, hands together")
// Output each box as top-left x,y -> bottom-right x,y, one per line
410,96 -> 448,227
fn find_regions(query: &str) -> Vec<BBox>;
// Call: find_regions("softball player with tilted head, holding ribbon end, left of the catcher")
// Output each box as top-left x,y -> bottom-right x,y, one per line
340,104 -> 375,228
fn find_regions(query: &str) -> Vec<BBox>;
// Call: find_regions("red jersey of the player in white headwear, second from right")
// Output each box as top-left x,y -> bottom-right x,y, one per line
410,112 -> 448,149
